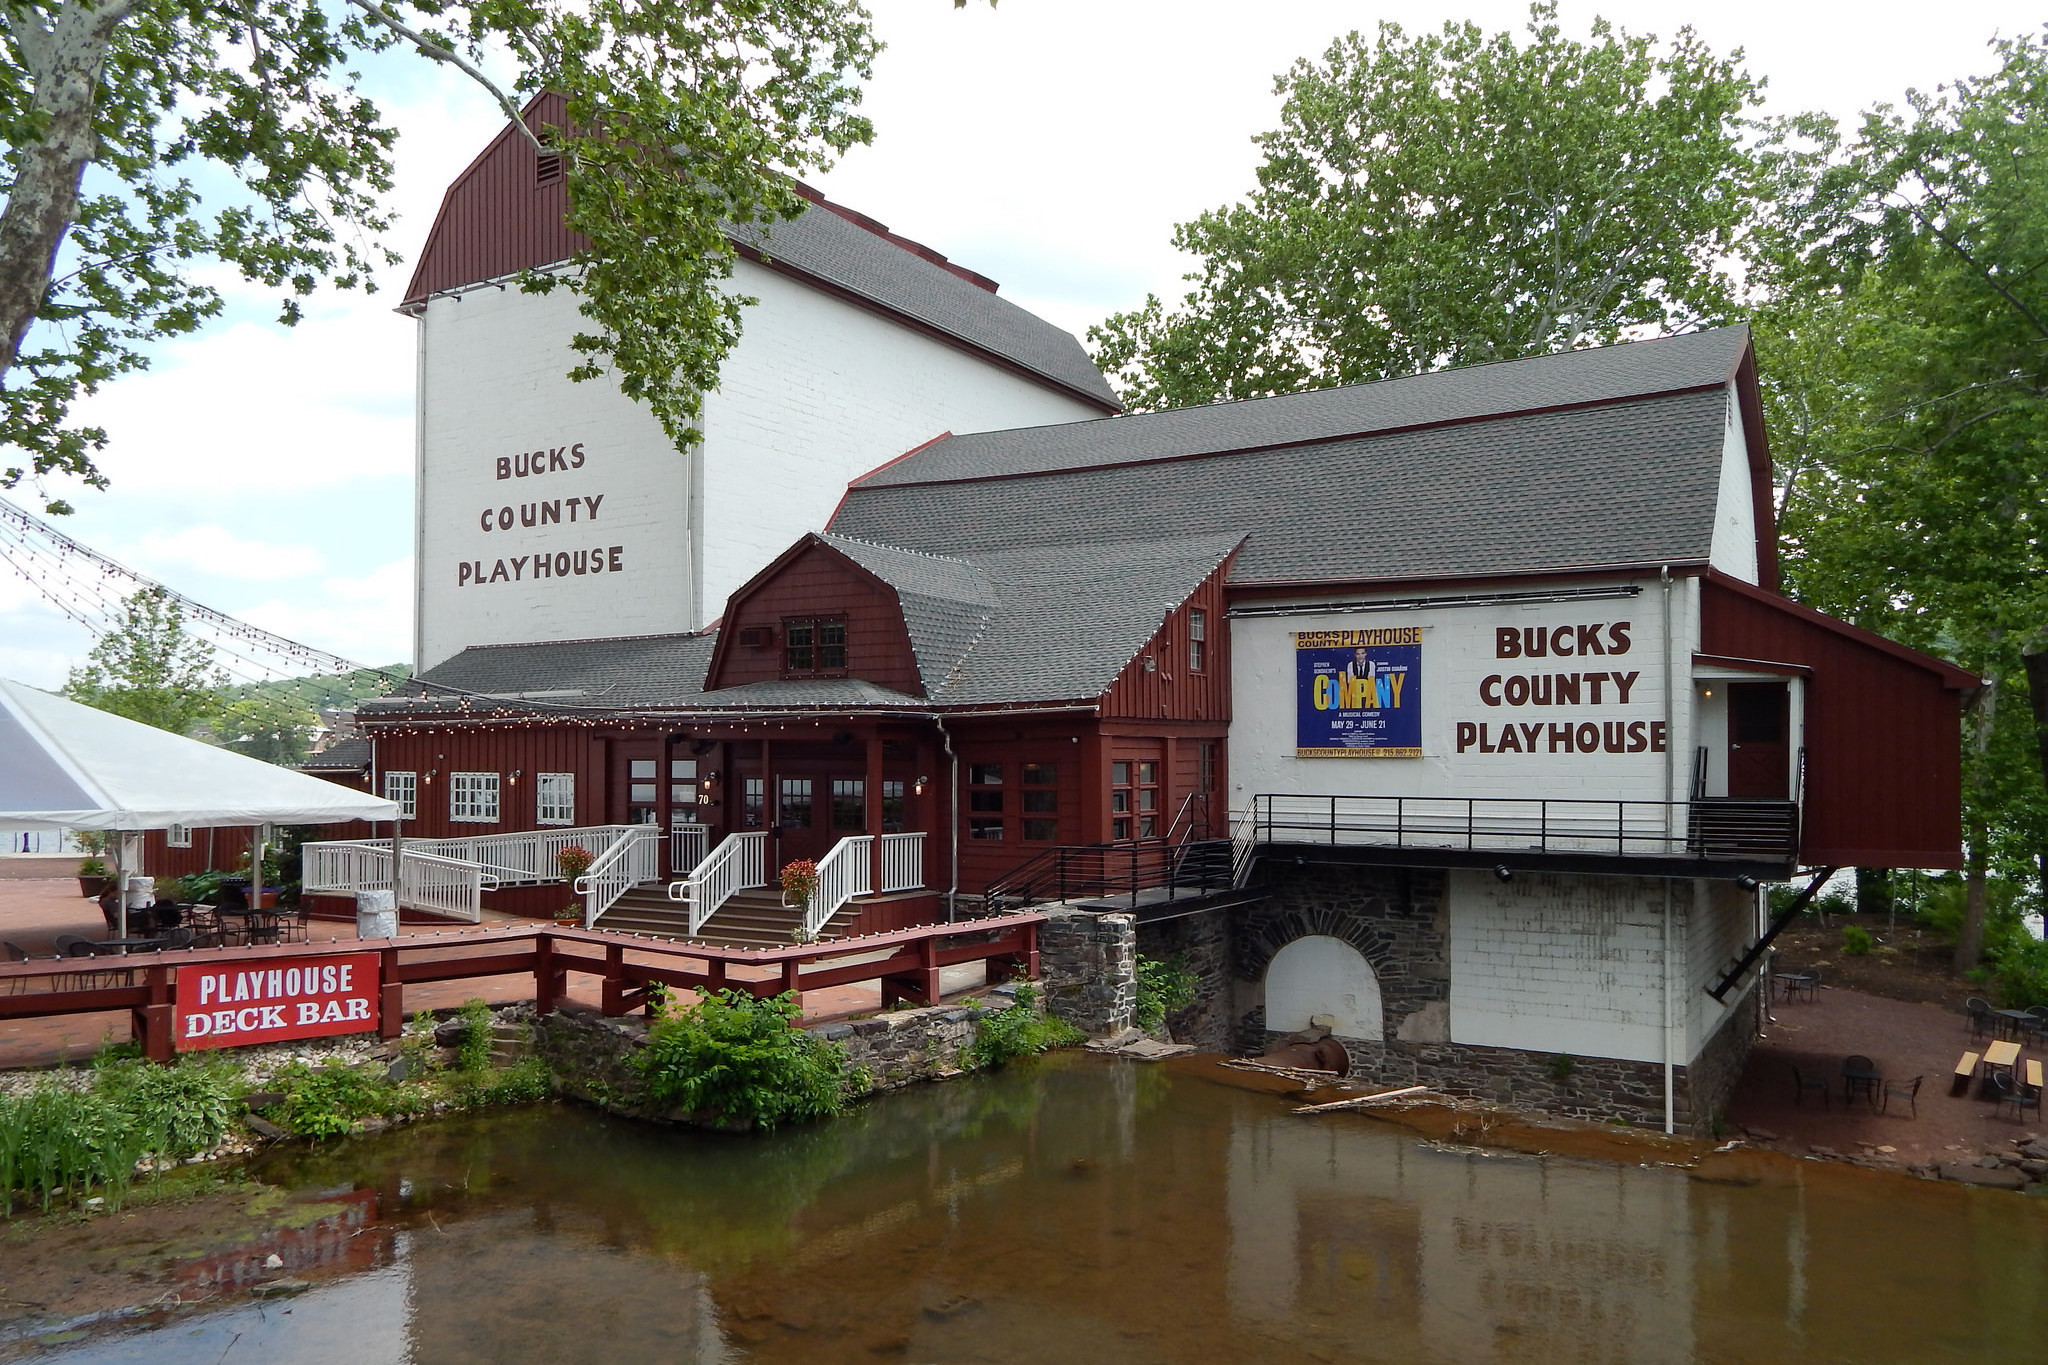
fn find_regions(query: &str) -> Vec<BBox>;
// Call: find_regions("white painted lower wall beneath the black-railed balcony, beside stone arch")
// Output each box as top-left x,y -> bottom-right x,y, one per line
1446,870 -> 1692,1062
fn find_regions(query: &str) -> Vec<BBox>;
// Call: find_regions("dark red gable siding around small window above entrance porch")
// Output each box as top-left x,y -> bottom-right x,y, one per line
705,540 -> 924,696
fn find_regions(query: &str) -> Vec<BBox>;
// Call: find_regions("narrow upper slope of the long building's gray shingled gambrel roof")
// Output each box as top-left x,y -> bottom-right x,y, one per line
854,327 -> 1749,489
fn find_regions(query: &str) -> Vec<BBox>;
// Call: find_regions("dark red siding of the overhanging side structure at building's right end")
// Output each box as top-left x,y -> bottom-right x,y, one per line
1700,575 -> 1970,868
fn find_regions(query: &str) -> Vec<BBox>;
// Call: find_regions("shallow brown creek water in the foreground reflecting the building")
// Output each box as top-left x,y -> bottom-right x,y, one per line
16,1054 -> 2048,1365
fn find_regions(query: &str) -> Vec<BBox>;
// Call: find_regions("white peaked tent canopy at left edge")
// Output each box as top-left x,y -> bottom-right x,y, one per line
0,677 -> 397,831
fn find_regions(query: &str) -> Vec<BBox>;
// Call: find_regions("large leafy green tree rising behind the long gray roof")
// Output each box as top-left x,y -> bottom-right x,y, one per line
1090,0 -> 1759,409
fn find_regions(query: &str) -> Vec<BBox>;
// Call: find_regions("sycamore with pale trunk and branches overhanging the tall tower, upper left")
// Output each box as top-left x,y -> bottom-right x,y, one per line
0,0 -> 879,512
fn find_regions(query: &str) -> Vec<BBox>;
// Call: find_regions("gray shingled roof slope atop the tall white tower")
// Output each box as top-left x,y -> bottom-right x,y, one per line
727,207 -> 1122,411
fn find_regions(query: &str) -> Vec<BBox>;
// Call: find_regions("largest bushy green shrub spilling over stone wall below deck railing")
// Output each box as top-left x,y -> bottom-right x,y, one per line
633,990 -> 846,1128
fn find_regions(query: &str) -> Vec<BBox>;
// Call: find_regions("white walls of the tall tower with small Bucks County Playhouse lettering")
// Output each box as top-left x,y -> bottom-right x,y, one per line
416,262 -> 1102,667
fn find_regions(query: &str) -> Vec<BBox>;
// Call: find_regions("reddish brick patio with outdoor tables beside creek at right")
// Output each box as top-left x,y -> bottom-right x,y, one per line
1729,986 -> 2040,1164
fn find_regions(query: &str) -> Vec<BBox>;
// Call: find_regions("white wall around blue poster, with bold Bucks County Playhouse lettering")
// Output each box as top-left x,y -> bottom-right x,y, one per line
1231,577 -> 1698,814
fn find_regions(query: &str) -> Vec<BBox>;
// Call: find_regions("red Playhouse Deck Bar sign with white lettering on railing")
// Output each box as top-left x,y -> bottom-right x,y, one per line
176,954 -> 377,1052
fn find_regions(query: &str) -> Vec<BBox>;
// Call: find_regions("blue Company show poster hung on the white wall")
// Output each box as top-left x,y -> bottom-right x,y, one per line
1294,626 -> 1421,759
